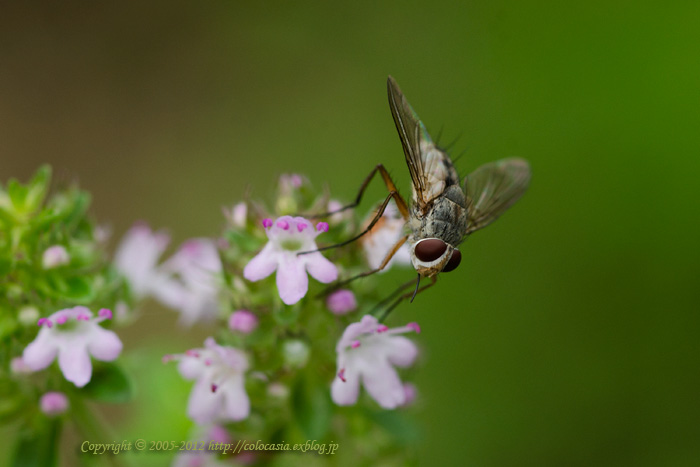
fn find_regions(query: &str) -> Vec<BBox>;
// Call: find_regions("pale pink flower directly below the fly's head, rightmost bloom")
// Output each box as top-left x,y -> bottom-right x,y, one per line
331,315 -> 420,409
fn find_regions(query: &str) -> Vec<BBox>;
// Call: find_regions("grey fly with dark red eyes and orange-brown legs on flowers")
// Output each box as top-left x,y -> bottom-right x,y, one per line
300,76 -> 530,315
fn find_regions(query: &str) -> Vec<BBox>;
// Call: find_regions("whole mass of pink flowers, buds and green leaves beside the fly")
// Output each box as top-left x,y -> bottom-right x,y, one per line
0,169 -> 420,465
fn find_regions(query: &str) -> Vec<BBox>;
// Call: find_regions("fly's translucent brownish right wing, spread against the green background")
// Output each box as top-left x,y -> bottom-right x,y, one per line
464,159 -> 530,235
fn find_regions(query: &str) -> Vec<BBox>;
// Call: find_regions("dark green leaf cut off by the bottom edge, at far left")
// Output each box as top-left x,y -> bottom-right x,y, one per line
11,419 -> 61,467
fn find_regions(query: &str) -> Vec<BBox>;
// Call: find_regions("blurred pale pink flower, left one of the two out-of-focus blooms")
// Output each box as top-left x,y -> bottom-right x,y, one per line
114,224 -> 170,298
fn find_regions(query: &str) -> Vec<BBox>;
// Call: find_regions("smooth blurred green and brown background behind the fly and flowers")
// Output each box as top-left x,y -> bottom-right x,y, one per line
0,0 -> 700,466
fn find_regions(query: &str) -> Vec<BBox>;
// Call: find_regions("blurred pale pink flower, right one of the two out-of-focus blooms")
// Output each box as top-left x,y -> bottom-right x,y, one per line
153,238 -> 223,326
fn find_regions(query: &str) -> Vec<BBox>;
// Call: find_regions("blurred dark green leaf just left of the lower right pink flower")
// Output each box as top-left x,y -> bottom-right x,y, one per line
292,372 -> 333,440
